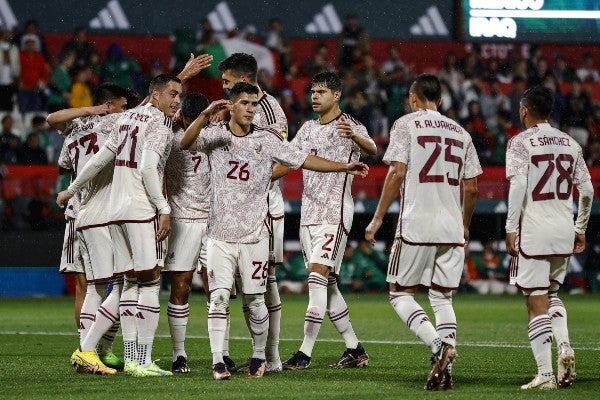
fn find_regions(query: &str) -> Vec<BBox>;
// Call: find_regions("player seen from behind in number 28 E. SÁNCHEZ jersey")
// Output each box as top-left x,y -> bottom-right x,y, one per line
506,86 -> 594,389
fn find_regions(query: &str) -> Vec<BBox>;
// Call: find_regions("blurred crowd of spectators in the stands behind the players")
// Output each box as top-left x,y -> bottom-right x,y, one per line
0,14 -> 600,166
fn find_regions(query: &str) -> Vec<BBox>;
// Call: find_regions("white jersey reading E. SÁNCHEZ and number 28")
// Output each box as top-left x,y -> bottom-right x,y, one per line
506,123 -> 591,256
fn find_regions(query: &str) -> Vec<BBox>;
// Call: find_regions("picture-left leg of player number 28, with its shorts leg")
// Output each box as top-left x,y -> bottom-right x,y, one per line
516,255 -> 556,389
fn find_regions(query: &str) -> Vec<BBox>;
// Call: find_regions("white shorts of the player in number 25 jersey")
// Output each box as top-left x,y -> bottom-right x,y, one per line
387,238 -> 465,290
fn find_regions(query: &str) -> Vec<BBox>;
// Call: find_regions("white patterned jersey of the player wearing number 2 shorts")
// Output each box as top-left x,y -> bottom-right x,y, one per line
291,113 -> 374,232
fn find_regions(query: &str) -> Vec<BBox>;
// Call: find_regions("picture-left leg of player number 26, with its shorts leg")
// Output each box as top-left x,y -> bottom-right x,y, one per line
206,238 -> 237,380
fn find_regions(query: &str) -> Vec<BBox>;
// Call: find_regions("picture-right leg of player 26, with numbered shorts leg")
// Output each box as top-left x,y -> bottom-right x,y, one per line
238,238 -> 269,378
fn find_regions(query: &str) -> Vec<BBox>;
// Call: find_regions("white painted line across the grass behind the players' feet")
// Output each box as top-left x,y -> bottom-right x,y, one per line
0,331 -> 600,351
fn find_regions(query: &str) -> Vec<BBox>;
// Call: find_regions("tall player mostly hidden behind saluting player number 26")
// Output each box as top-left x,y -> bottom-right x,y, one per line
219,53 -> 288,372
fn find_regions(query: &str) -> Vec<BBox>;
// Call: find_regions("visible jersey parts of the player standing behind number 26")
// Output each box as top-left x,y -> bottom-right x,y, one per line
252,92 -> 288,217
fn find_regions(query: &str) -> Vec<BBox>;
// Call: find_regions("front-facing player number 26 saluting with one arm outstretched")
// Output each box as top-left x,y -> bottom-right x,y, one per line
180,82 -> 368,380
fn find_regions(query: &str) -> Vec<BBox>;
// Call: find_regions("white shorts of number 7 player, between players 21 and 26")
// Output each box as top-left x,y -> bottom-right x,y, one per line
163,219 -> 208,272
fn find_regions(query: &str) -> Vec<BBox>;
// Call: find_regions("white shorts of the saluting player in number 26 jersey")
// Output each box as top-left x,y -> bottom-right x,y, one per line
206,237 -> 269,294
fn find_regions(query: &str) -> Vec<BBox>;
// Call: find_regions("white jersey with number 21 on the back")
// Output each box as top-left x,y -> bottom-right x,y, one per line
106,104 -> 173,222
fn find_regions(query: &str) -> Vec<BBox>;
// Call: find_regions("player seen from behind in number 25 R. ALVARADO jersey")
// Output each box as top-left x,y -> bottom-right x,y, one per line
365,74 -> 482,390
